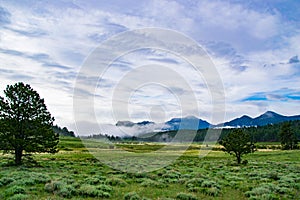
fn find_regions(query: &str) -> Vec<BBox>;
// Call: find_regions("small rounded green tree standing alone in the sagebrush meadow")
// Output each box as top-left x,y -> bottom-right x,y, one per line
219,129 -> 255,164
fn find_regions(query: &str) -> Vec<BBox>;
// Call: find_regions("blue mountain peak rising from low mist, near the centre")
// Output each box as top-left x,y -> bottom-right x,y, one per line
164,116 -> 211,131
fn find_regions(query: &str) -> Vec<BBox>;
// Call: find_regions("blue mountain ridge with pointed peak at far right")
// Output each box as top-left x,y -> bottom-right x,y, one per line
224,111 -> 300,127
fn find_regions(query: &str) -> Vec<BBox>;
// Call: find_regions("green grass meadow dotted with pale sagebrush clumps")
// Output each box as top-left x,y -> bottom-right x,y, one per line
0,137 -> 300,200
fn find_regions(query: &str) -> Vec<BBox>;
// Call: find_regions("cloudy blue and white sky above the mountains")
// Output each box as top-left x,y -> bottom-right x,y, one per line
0,0 -> 300,136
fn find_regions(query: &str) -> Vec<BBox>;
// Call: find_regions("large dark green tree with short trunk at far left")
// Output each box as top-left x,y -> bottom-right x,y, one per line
0,82 -> 59,165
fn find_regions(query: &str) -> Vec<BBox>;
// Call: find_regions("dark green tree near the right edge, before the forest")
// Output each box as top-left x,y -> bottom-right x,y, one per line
279,122 -> 298,150
